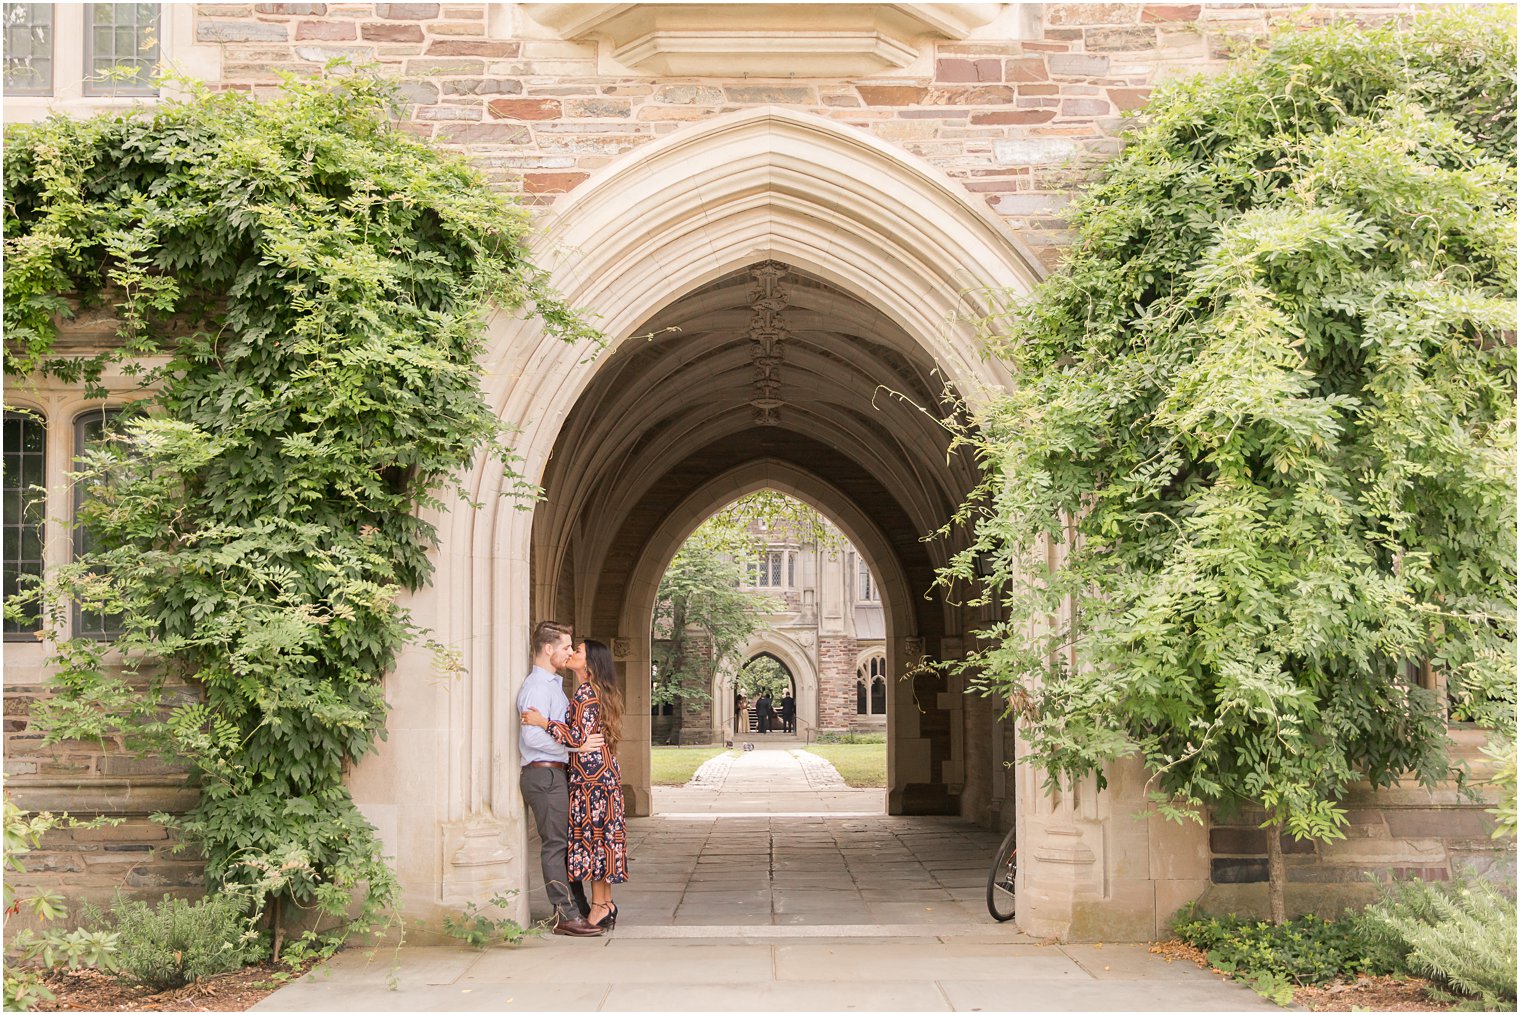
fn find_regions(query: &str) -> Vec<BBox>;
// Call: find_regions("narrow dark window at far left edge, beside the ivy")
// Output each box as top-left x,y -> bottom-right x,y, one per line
5,412 -> 47,641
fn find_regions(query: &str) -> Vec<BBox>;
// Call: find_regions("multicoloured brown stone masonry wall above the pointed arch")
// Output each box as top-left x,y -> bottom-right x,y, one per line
196,3 -> 1398,266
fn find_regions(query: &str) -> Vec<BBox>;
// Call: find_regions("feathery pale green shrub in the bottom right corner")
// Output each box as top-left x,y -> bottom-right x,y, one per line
1363,878 -> 1515,1007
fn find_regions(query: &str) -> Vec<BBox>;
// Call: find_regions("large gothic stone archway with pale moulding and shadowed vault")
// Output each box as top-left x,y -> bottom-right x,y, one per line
354,108 -> 1209,936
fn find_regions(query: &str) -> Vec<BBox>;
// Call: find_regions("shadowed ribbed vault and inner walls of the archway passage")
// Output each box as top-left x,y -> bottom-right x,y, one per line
535,258 -> 976,814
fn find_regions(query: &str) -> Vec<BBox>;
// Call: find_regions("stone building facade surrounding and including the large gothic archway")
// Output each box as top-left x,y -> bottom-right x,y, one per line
5,3 -> 1512,939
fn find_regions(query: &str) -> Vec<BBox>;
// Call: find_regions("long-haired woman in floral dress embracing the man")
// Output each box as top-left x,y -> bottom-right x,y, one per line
523,638 -> 628,930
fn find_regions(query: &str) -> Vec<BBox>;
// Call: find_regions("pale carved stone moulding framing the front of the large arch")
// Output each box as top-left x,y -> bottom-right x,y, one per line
422,106 -> 1041,915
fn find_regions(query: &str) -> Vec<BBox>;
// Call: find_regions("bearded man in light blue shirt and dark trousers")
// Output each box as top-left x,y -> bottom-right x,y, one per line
517,620 -> 602,938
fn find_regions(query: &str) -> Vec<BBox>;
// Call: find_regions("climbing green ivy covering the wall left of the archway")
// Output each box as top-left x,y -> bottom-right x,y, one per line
5,65 -> 594,954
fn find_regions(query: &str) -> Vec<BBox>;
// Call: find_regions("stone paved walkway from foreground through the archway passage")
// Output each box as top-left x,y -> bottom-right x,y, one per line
255,745 -> 1275,1012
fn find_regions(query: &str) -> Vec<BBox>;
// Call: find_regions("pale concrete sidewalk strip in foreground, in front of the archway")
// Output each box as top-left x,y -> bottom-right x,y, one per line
254,927 -> 1280,1012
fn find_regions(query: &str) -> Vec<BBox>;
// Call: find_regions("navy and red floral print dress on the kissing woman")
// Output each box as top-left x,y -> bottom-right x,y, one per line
549,684 -> 628,884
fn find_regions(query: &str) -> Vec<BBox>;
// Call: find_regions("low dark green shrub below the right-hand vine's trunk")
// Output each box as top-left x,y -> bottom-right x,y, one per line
1172,907 -> 1397,997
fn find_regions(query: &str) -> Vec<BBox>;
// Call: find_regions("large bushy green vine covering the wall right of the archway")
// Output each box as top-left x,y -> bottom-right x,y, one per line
942,9 -> 1515,921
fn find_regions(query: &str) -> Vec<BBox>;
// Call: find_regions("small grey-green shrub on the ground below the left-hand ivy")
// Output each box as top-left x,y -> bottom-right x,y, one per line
84,893 -> 264,991
